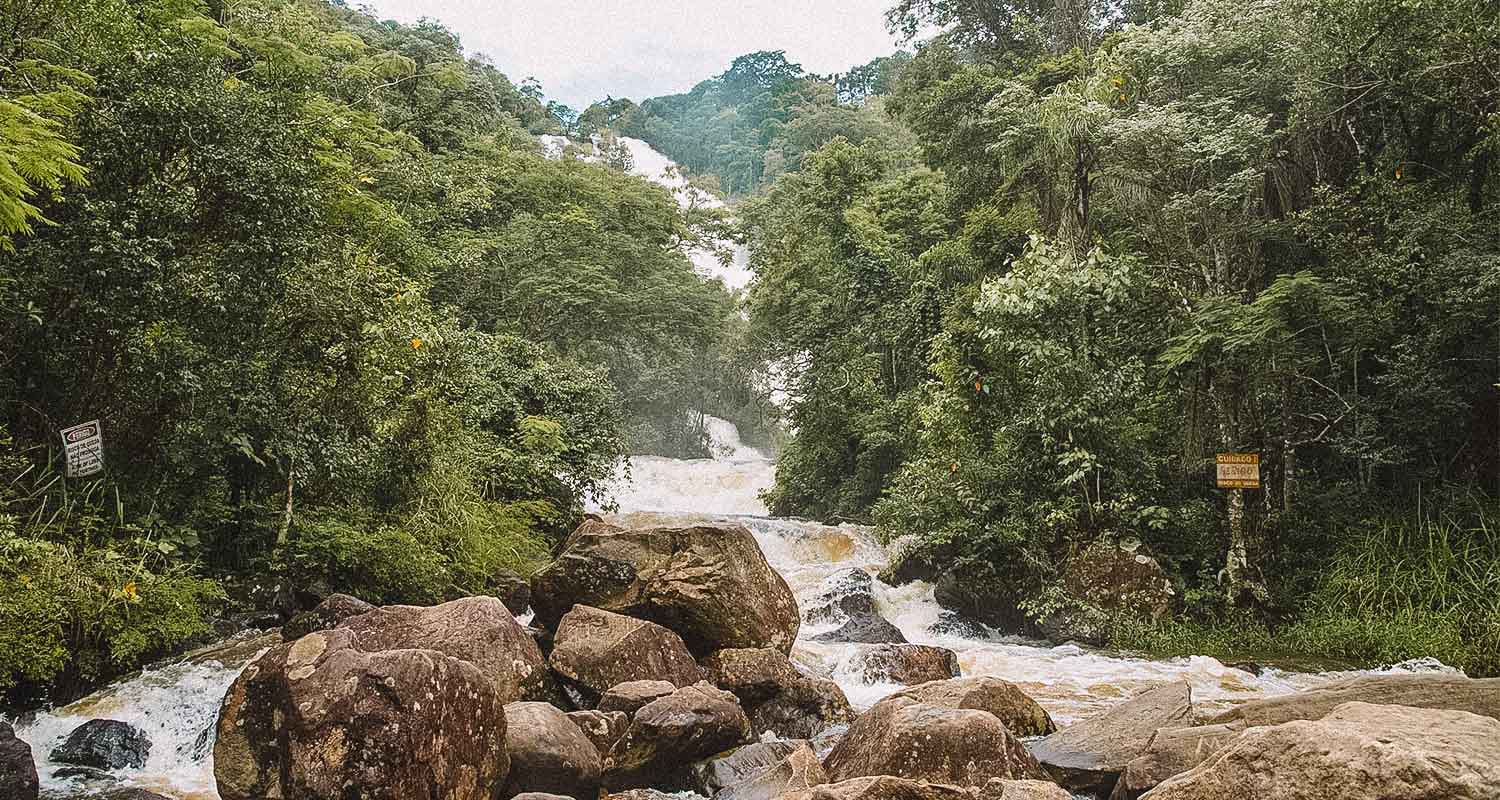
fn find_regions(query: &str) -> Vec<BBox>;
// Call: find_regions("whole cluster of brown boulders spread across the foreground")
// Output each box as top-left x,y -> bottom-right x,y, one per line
0,521 -> 1500,800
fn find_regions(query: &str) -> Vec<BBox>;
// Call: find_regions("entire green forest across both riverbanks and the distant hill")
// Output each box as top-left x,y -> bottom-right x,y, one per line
0,0 -> 1500,704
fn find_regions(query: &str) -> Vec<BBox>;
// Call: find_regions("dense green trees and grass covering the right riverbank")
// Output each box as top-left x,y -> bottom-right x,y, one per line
750,0 -> 1500,672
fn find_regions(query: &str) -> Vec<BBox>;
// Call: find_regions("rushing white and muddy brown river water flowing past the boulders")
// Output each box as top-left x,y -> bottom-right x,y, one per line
0,140 -> 1448,800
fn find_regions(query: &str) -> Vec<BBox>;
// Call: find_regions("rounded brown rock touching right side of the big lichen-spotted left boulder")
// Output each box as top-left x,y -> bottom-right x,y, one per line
501,702 -> 602,797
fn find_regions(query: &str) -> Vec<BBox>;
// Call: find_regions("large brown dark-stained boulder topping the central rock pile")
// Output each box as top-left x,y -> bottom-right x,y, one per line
531,521 -> 801,656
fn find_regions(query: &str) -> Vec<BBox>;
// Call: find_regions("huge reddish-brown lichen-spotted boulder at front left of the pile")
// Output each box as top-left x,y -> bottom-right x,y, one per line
213,627 -> 515,800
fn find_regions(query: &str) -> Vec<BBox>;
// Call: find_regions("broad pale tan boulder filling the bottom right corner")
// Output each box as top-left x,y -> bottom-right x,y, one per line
1146,702 -> 1500,800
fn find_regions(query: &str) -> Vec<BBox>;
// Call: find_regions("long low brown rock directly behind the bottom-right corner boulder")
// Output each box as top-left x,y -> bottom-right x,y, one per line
1208,672 -> 1500,728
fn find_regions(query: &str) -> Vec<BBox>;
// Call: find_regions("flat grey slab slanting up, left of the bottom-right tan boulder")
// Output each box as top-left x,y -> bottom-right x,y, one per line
1031,680 -> 1193,795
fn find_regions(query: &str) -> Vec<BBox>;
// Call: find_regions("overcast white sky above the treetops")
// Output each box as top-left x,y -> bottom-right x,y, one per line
350,0 -> 897,111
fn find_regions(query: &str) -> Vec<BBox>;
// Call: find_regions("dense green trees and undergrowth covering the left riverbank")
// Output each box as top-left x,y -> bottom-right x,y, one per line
0,0 -> 734,699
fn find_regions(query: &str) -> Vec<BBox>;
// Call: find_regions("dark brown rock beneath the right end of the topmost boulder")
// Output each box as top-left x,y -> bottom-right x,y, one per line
704,648 -> 854,738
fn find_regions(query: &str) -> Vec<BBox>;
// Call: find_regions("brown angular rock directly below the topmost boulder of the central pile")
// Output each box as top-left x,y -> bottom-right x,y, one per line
549,605 -> 702,707
